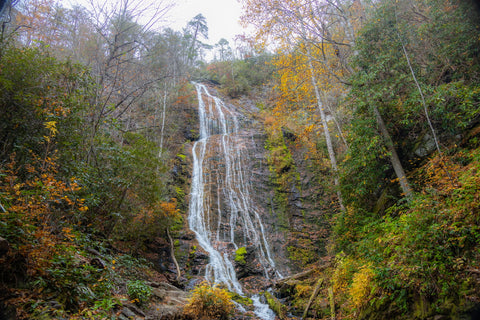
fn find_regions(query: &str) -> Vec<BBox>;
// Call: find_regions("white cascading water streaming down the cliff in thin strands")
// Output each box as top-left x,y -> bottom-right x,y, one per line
188,83 -> 280,320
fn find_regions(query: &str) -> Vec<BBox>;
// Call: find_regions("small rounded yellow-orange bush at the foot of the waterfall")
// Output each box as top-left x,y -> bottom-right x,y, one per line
184,282 -> 234,319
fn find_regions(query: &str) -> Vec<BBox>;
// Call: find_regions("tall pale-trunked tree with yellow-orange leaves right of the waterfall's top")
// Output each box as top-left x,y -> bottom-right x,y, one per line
240,1 -> 356,209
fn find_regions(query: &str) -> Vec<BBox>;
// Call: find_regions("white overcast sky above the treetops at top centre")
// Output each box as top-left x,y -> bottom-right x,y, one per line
65,0 -> 244,47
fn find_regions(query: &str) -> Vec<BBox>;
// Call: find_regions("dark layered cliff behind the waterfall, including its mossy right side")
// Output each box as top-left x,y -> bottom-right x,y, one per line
172,84 -> 335,304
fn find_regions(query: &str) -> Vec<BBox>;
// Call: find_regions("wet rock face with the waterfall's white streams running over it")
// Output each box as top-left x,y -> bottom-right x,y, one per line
186,85 -> 289,300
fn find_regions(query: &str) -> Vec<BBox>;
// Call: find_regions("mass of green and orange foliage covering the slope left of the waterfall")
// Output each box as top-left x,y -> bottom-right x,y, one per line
0,6 -> 187,319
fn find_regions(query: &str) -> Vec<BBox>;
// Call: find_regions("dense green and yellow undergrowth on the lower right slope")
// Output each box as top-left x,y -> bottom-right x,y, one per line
332,149 -> 480,319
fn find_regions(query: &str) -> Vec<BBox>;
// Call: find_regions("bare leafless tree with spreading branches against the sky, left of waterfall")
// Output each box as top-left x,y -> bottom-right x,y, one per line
82,0 -> 172,157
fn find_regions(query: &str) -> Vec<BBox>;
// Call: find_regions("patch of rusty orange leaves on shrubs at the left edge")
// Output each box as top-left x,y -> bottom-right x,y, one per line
0,154 -> 86,276
